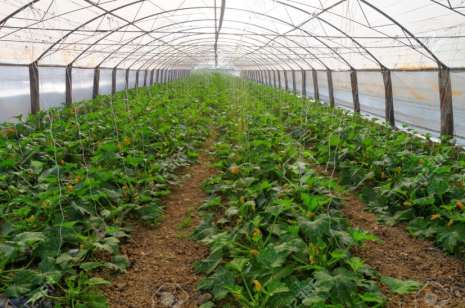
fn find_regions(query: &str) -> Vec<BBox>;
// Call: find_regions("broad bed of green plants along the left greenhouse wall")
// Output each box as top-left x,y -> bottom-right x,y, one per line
0,77 -> 218,307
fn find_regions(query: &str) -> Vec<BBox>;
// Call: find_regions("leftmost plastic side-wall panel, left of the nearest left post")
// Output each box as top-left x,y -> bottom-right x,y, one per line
0,66 -> 31,122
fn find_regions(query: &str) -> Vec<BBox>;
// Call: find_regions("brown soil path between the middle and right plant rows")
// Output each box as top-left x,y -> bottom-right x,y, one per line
316,168 -> 465,308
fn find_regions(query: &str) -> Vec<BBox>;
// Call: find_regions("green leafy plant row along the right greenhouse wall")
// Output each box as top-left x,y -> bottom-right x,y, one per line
248,82 -> 465,254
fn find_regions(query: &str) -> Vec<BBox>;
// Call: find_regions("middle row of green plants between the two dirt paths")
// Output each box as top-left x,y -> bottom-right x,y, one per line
194,77 -> 418,307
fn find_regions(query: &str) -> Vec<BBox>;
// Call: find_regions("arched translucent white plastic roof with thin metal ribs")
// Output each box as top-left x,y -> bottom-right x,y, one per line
0,0 -> 465,70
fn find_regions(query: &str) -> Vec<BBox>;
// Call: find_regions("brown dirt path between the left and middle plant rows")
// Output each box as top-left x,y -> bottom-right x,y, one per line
104,140 -> 214,308
